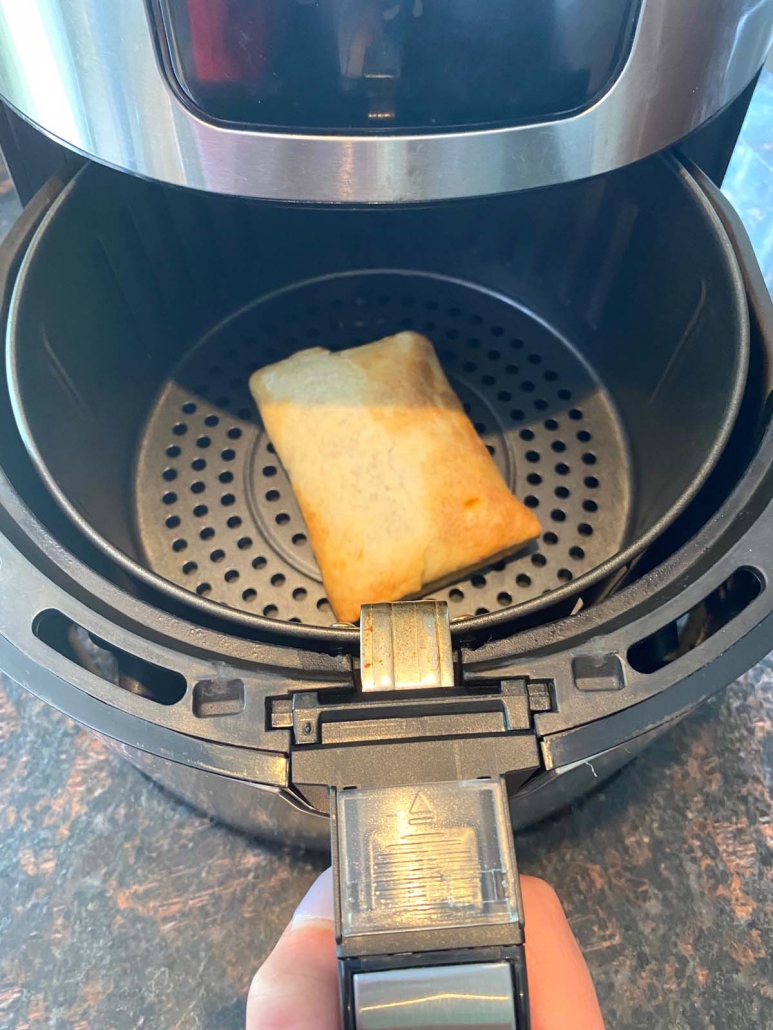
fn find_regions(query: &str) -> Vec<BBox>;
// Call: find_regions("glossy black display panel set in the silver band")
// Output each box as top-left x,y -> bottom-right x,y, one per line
159,0 -> 639,131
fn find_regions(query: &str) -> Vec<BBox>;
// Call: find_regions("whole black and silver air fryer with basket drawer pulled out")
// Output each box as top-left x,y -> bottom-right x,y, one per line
0,0 -> 773,1030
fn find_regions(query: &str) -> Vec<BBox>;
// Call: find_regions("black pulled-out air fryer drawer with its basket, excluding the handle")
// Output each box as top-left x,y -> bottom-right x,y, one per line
0,150 -> 773,845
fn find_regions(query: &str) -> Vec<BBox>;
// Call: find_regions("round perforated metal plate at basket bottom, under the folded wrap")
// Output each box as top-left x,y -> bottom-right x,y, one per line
135,271 -> 631,625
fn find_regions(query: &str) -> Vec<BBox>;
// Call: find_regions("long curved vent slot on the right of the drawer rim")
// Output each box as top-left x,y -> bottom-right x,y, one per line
628,569 -> 764,674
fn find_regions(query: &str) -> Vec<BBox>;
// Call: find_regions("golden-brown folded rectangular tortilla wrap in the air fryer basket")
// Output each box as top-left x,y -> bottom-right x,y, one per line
249,332 -> 541,622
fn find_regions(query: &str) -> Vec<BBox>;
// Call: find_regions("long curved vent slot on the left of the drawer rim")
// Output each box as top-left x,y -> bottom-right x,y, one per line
32,609 -> 187,705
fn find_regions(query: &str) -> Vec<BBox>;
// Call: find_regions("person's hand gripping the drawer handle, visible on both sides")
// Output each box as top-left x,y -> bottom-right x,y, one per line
246,869 -> 604,1030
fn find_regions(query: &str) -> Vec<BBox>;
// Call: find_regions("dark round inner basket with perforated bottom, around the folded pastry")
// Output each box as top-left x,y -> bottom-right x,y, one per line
8,158 -> 748,625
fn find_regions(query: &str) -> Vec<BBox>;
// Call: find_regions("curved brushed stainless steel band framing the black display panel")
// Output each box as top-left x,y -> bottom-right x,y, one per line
0,0 -> 773,203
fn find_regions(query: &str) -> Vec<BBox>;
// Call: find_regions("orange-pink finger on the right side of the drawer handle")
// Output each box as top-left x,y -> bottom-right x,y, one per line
520,877 -> 604,1030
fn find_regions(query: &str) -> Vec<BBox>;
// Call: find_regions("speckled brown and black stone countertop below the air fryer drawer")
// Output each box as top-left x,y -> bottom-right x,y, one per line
0,659 -> 773,1030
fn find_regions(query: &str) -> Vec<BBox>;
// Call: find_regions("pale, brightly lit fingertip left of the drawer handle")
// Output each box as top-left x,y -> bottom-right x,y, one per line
247,869 -> 339,1030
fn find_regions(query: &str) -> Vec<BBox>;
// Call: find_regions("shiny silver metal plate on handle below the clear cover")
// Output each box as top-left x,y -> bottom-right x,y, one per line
355,962 -> 516,1030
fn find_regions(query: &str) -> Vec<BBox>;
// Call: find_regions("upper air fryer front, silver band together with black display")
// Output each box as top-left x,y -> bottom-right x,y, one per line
0,0 -> 773,203
